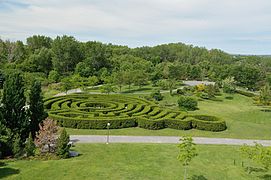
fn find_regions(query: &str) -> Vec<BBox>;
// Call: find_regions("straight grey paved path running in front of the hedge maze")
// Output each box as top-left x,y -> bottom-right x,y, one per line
70,135 -> 271,146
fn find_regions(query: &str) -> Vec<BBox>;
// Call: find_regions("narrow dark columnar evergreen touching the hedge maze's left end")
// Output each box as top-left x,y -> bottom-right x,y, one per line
29,81 -> 46,137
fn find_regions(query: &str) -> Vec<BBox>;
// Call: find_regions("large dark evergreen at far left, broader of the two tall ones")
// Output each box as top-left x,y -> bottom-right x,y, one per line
2,72 -> 29,141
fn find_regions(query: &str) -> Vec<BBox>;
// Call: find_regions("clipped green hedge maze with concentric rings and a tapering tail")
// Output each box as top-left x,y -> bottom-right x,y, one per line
44,94 -> 226,131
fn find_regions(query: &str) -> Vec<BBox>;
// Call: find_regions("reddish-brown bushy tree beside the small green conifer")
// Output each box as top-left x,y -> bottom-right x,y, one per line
35,118 -> 58,153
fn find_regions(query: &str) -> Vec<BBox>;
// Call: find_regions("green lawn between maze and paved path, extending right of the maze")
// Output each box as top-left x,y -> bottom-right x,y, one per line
67,94 -> 271,139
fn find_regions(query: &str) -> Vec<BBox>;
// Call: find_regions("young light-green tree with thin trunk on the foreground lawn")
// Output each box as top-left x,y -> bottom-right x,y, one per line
177,137 -> 198,180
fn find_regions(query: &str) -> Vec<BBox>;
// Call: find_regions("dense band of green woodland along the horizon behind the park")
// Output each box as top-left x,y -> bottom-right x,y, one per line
0,35 -> 271,90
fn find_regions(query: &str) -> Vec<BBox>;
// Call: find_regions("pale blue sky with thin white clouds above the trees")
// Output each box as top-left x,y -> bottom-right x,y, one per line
0,0 -> 271,55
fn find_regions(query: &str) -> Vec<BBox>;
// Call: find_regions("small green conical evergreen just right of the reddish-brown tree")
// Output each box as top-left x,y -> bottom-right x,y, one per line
56,129 -> 71,158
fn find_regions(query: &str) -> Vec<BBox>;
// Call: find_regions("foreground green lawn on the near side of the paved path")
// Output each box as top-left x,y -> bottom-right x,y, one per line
0,144 -> 271,180
